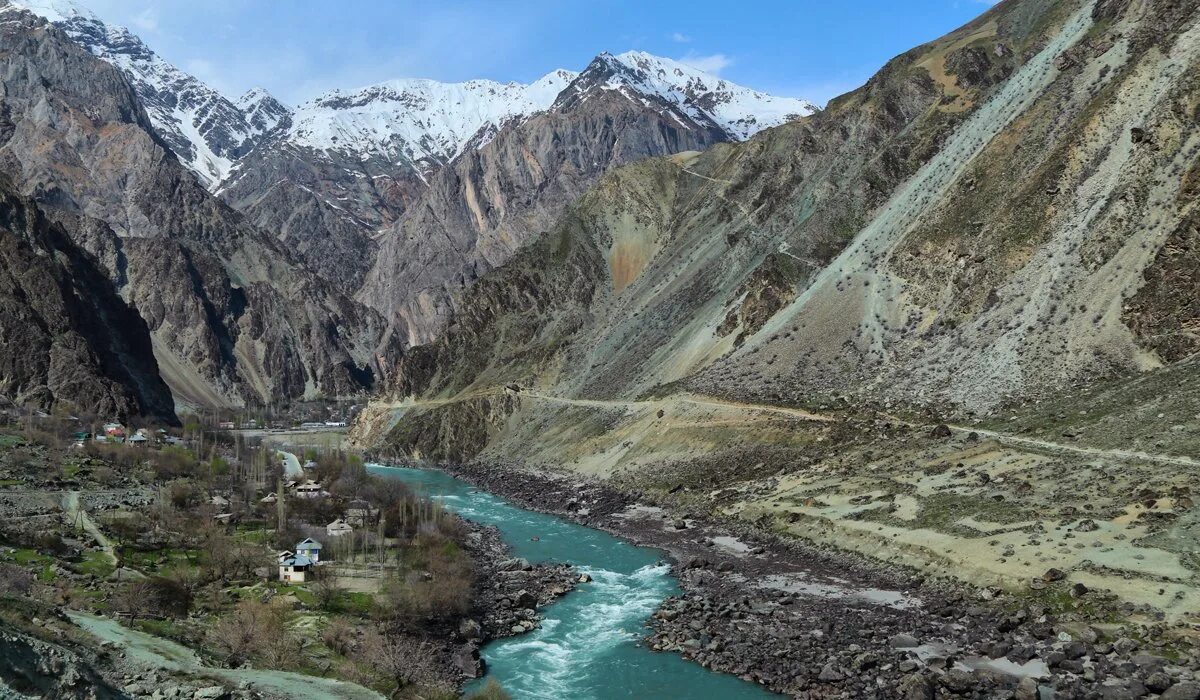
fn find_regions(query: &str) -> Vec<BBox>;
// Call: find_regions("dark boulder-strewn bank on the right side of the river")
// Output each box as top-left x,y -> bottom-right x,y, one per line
415,465 -> 1200,698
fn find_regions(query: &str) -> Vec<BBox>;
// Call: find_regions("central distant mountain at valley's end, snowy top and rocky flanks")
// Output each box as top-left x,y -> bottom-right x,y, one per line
220,53 -> 815,319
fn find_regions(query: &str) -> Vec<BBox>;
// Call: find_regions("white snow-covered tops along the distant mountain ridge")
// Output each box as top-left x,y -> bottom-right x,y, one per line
11,0 -> 816,190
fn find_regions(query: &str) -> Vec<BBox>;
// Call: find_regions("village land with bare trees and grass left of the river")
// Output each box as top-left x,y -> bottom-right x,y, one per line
0,417 -> 572,698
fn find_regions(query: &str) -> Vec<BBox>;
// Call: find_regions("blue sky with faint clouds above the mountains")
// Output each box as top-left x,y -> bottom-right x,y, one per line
82,0 -> 990,104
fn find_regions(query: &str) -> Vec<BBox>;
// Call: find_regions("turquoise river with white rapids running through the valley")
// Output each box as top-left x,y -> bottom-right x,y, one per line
372,466 -> 776,700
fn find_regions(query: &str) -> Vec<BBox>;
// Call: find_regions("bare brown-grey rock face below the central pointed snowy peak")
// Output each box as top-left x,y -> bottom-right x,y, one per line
359,69 -> 728,345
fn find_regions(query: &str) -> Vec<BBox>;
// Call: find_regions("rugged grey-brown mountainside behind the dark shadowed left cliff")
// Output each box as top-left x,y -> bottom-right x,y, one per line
0,8 -> 386,406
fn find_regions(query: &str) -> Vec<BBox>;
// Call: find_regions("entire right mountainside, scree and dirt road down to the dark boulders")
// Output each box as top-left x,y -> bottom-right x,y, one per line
356,0 -> 1200,621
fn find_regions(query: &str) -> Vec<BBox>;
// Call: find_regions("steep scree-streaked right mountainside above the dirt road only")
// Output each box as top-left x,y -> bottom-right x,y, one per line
364,0 -> 1200,444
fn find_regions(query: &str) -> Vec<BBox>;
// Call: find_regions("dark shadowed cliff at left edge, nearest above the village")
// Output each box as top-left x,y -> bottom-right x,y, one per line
0,181 -> 174,420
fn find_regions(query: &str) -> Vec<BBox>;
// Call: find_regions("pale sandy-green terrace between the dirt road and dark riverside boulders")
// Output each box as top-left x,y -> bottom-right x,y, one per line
355,390 -> 1200,626
